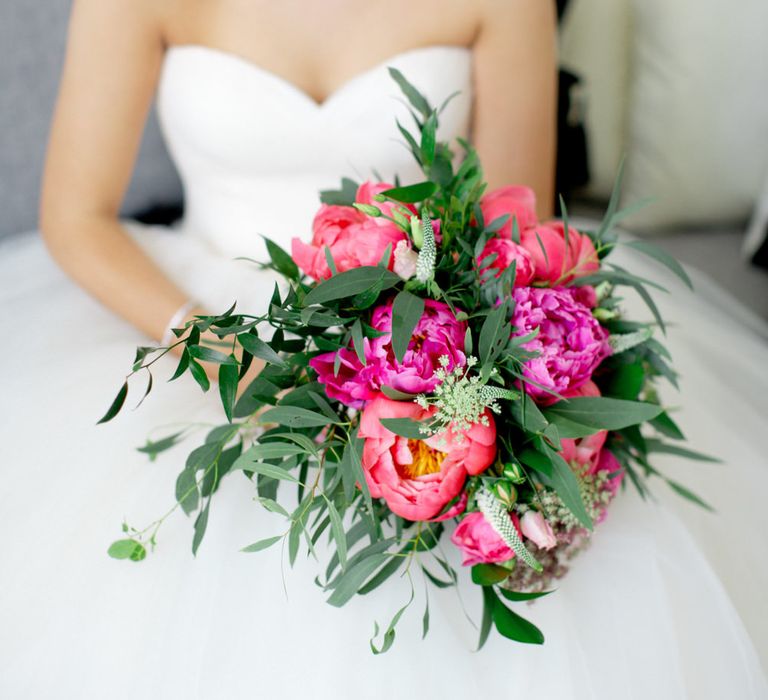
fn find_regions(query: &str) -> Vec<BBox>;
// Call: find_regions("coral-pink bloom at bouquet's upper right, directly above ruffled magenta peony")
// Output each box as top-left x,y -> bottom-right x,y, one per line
520,221 -> 600,287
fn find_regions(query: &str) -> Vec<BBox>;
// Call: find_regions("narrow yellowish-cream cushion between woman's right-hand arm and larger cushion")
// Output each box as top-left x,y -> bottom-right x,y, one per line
560,0 -> 632,199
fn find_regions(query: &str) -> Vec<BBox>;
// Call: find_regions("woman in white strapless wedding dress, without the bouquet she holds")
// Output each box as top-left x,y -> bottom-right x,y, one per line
0,0 -> 768,700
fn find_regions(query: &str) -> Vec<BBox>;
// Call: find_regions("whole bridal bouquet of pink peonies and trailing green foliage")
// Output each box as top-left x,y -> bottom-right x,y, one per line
102,70 -> 706,653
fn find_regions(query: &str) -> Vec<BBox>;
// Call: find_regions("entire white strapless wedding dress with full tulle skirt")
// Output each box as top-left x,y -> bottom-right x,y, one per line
0,45 -> 768,700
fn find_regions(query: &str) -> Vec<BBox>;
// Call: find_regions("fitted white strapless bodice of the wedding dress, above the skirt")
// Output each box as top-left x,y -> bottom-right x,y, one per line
157,45 -> 472,256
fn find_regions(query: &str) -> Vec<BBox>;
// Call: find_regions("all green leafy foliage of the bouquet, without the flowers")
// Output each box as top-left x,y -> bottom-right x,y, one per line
100,68 -> 708,653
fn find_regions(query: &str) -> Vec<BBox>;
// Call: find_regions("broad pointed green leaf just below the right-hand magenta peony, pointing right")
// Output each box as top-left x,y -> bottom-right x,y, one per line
544,396 -> 663,436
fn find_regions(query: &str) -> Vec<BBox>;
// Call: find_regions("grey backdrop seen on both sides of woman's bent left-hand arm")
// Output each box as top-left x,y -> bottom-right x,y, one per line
0,0 -> 182,238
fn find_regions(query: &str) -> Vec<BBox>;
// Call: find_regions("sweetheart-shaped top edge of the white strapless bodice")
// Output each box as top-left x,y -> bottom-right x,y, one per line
166,43 -> 472,111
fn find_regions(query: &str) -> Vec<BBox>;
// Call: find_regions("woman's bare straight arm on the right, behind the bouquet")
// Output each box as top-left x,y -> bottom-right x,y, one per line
473,0 -> 557,217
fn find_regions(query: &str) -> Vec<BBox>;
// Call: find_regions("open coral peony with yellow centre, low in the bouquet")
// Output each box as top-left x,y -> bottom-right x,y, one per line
359,395 -> 496,520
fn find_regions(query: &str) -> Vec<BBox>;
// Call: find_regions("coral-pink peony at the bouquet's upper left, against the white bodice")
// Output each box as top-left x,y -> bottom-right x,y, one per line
291,182 -> 409,280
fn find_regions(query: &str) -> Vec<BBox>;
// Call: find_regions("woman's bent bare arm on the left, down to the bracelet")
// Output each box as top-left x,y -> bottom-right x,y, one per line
40,0 -> 201,348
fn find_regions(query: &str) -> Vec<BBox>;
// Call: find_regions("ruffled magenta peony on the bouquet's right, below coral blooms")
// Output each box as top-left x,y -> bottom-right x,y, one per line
512,287 -> 611,405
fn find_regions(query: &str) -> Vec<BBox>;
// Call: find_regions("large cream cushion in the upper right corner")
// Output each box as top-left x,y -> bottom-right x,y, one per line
620,0 -> 768,229
